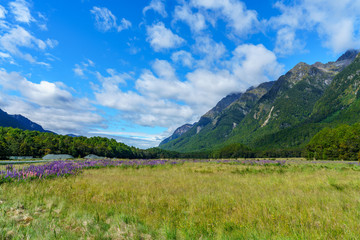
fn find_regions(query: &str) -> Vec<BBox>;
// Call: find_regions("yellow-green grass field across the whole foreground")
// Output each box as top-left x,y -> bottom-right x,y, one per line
0,162 -> 360,239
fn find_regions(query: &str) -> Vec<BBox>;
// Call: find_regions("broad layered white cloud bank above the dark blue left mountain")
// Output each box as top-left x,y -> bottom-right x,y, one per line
0,69 -> 103,133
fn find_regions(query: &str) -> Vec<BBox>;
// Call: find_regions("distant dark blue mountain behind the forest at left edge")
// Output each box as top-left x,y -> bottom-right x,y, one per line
0,109 -> 50,132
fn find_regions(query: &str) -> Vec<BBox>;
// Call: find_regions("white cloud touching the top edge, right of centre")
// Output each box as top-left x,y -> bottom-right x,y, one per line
190,0 -> 260,37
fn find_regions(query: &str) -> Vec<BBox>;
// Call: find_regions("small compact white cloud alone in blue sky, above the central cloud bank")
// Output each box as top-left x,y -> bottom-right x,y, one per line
146,22 -> 185,52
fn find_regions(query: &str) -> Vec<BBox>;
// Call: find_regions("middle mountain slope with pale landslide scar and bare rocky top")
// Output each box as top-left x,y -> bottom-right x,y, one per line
229,57 -> 348,146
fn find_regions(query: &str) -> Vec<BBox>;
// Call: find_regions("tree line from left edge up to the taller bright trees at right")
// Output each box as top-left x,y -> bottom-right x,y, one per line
0,127 -> 310,159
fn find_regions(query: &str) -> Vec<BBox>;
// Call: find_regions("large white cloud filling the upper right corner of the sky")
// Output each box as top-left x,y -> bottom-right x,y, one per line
269,0 -> 360,54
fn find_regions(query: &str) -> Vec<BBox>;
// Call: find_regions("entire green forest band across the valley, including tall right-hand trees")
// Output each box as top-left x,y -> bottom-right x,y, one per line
0,123 -> 360,160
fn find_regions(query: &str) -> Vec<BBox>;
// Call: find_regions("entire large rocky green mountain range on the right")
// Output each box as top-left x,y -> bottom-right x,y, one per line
160,50 -> 360,152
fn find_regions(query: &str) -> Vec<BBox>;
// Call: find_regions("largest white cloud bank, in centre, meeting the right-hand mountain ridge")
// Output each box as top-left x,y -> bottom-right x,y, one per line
95,44 -> 283,129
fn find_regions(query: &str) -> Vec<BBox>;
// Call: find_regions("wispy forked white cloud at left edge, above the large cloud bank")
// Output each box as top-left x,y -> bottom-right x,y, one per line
0,26 -> 57,66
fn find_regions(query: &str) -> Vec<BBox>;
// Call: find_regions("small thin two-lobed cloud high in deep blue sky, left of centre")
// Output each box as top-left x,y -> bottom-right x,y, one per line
90,7 -> 131,32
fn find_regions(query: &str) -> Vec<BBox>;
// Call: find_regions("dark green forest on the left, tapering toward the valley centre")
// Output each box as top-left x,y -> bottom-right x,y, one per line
0,127 -> 143,158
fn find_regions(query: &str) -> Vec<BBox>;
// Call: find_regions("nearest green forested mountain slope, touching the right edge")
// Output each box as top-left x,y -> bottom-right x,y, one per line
248,51 -> 360,149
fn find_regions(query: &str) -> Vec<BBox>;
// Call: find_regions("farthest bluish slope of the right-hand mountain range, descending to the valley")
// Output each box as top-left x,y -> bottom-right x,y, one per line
160,82 -> 273,152
